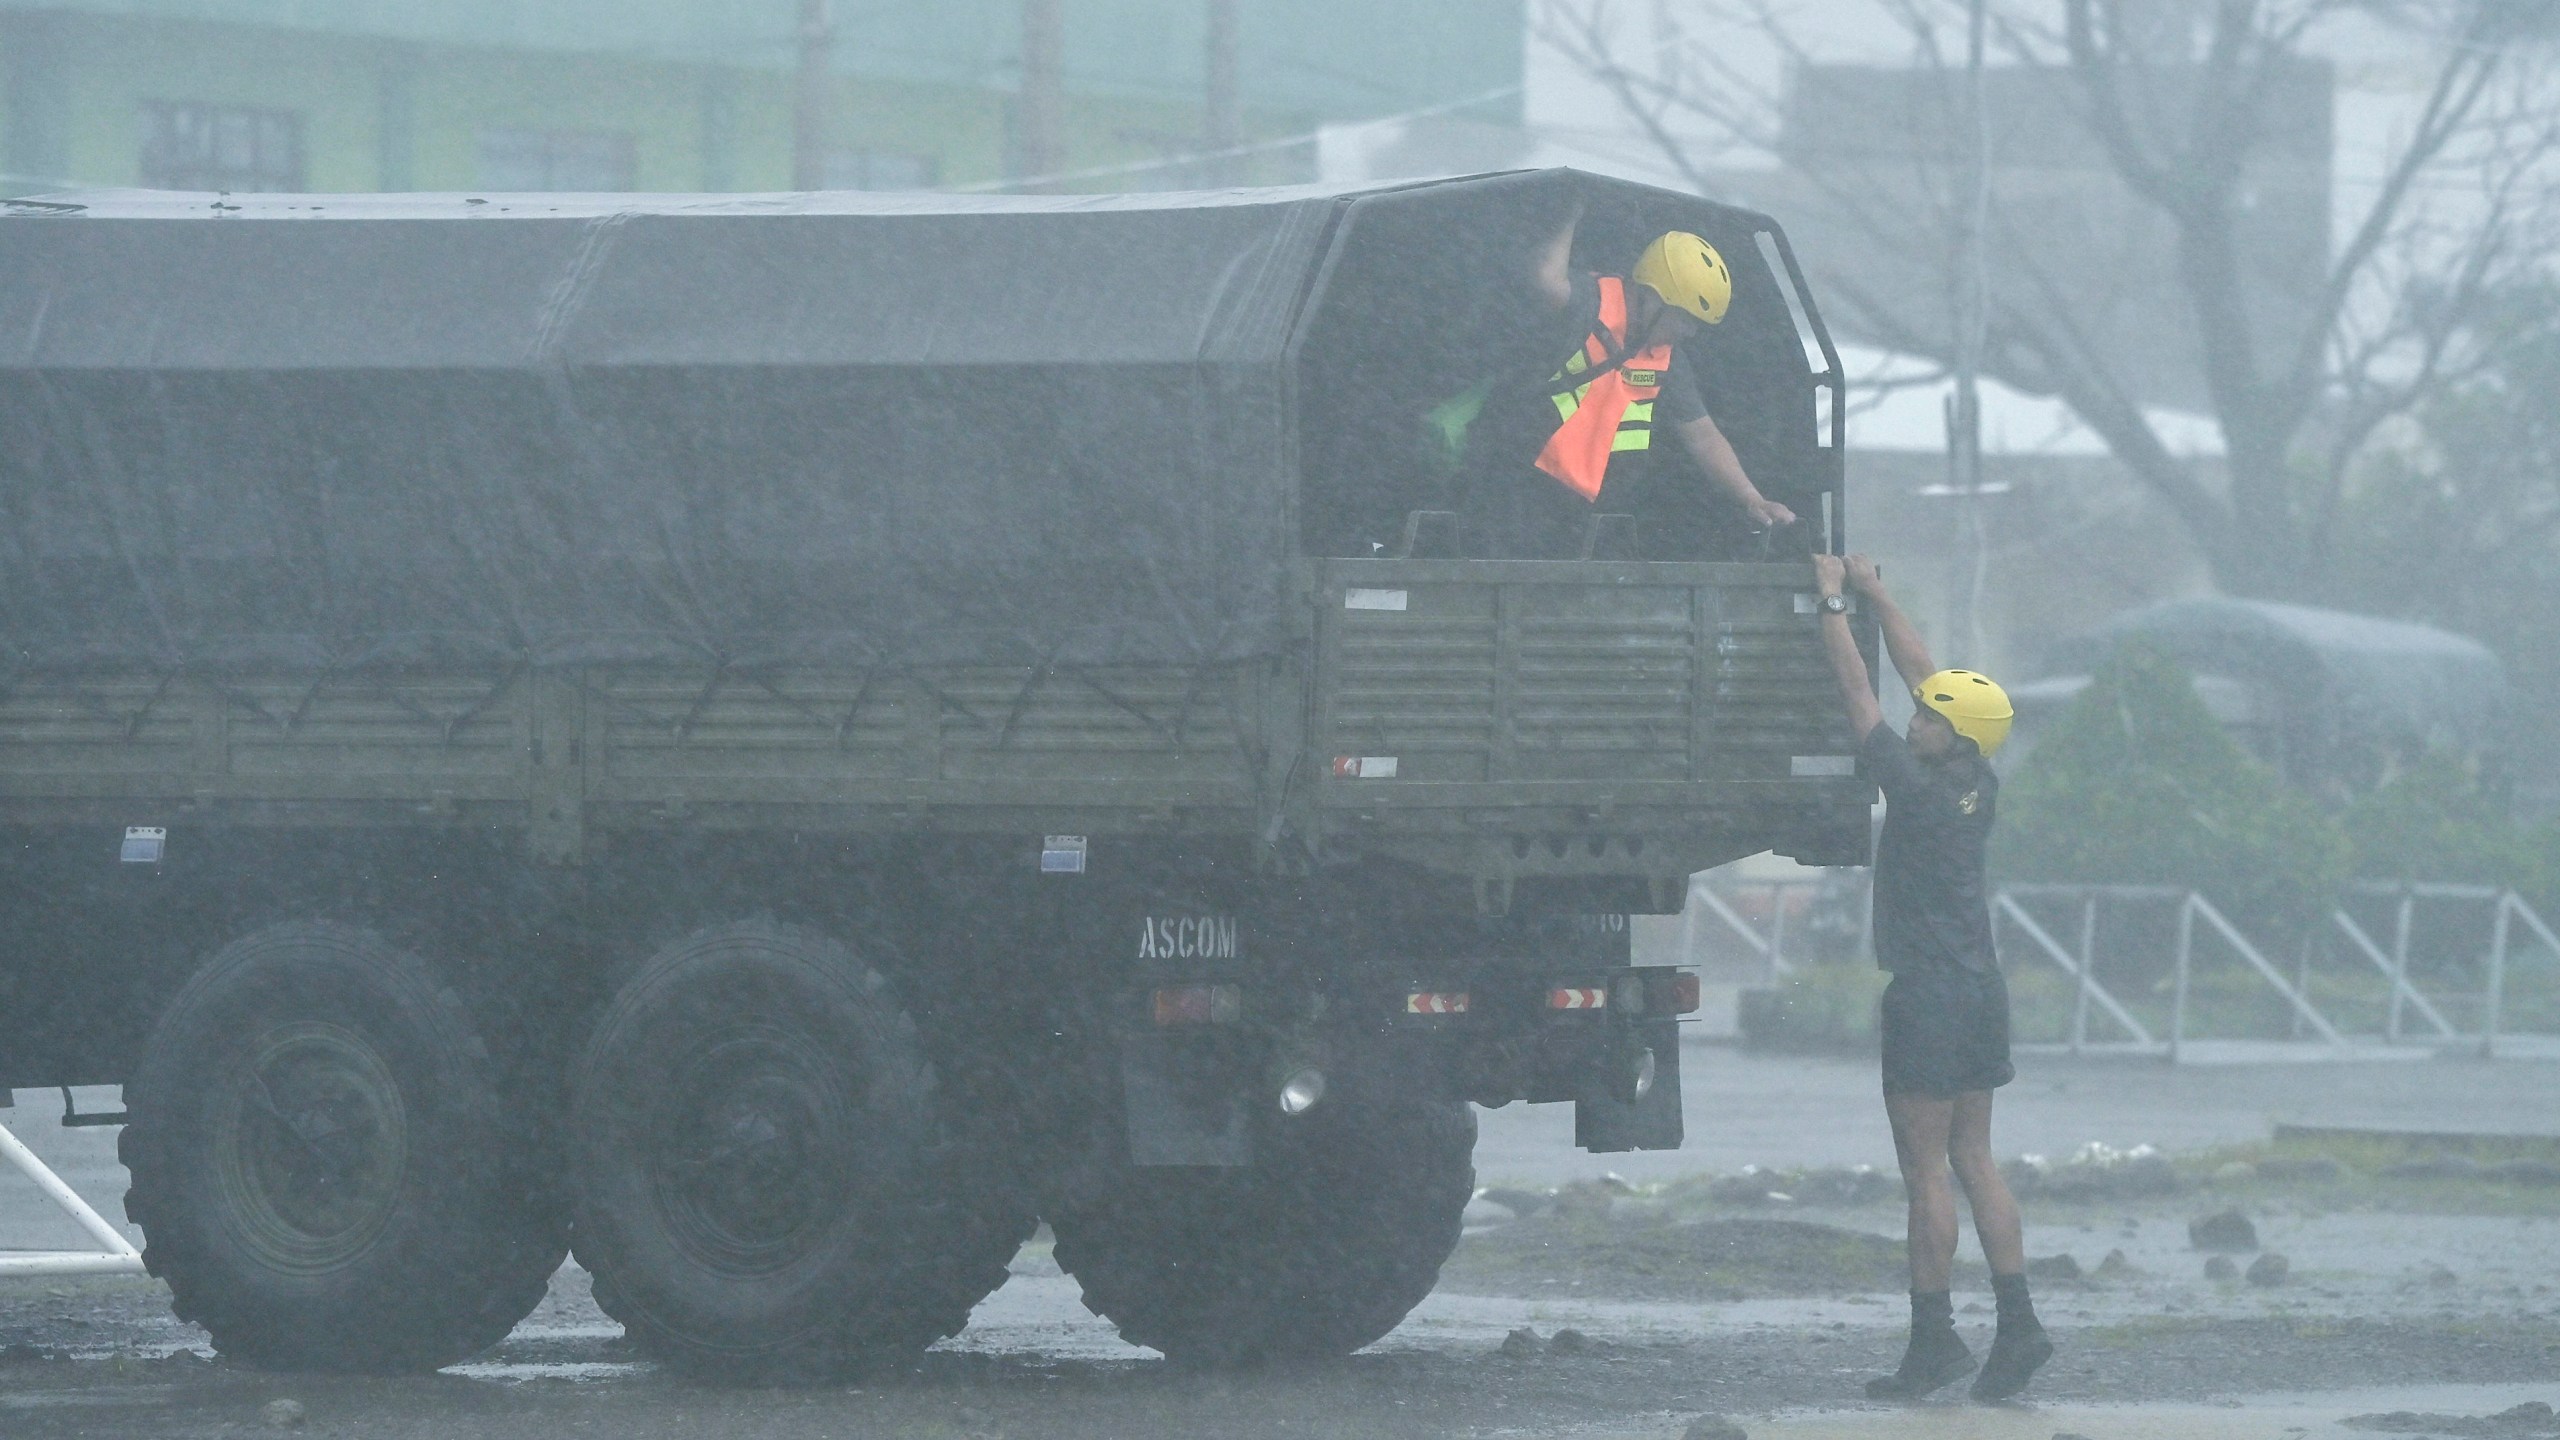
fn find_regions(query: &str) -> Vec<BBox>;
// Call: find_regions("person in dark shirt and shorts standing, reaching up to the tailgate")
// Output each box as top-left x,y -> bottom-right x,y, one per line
1812,543 -> 2053,1399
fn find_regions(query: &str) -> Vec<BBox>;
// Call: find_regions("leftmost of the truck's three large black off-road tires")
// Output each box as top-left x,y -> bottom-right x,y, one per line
118,922 -> 566,1373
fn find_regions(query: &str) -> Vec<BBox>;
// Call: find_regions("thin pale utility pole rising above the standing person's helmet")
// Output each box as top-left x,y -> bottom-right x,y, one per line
1946,0 -> 1992,666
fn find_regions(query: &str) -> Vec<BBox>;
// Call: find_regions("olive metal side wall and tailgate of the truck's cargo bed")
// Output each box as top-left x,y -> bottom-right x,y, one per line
0,561 -> 1869,884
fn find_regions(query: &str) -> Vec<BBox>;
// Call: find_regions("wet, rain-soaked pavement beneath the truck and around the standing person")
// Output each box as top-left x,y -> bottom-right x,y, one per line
0,1045 -> 2560,1440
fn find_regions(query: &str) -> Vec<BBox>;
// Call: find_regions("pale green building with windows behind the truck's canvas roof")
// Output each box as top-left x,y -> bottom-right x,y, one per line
0,0 -> 1523,192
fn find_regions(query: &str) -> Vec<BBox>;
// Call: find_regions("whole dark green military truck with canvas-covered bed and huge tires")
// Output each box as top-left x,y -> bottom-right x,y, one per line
0,172 -> 1871,1379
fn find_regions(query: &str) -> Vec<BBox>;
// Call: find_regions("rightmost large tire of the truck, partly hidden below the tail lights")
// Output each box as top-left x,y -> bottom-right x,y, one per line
1050,1099 -> 1475,1366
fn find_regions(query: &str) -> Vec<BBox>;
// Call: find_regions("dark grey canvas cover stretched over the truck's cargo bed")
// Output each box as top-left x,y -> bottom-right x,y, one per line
0,172 -> 1815,674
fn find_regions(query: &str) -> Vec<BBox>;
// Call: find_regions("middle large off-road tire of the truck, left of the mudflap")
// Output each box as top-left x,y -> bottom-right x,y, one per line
568,922 -> 1034,1384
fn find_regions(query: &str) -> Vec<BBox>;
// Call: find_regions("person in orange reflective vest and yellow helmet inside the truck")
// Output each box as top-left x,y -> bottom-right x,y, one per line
1477,215 -> 1795,559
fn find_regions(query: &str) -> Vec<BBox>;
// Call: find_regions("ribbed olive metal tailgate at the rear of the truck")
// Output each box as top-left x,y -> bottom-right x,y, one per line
1311,559 -> 1874,874
